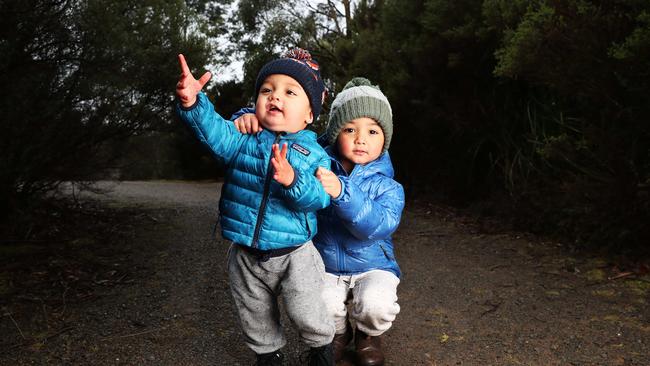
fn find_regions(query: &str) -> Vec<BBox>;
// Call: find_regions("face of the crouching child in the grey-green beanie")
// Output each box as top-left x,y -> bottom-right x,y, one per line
336,117 -> 384,172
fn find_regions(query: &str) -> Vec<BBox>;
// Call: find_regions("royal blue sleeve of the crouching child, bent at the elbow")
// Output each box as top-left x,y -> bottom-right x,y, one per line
332,176 -> 404,240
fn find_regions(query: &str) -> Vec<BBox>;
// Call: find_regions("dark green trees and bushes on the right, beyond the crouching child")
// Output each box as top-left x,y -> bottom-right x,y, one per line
225,0 -> 650,253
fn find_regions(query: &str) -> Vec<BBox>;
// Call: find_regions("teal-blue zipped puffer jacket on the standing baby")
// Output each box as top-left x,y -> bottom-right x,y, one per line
176,93 -> 330,250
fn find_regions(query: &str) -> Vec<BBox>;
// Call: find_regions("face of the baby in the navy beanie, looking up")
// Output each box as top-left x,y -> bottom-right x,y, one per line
255,74 -> 313,133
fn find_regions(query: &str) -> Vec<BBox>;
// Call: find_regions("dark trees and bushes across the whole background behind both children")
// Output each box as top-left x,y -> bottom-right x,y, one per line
0,0 -> 650,255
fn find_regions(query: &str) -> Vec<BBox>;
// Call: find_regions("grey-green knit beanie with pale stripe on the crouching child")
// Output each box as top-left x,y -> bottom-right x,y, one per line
325,77 -> 393,151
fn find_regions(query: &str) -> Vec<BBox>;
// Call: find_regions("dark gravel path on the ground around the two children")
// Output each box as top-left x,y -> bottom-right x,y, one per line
0,182 -> 650,365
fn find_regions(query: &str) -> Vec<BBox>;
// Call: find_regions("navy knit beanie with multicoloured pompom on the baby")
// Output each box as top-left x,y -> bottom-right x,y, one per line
255,48 -> 325,121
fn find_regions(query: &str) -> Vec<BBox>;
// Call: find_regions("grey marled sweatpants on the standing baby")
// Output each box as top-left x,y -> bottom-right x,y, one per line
228,241 -> 334,354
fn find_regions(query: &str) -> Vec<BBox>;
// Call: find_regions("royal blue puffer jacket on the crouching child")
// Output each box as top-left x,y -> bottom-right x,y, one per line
314,146 -> 404,277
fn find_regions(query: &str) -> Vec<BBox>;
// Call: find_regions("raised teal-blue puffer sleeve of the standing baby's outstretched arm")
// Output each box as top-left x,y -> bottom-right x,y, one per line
176,92 -> 244,164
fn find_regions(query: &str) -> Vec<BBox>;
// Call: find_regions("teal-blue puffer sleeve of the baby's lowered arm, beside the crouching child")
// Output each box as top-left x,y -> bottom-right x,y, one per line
283,152 -> 330,212
